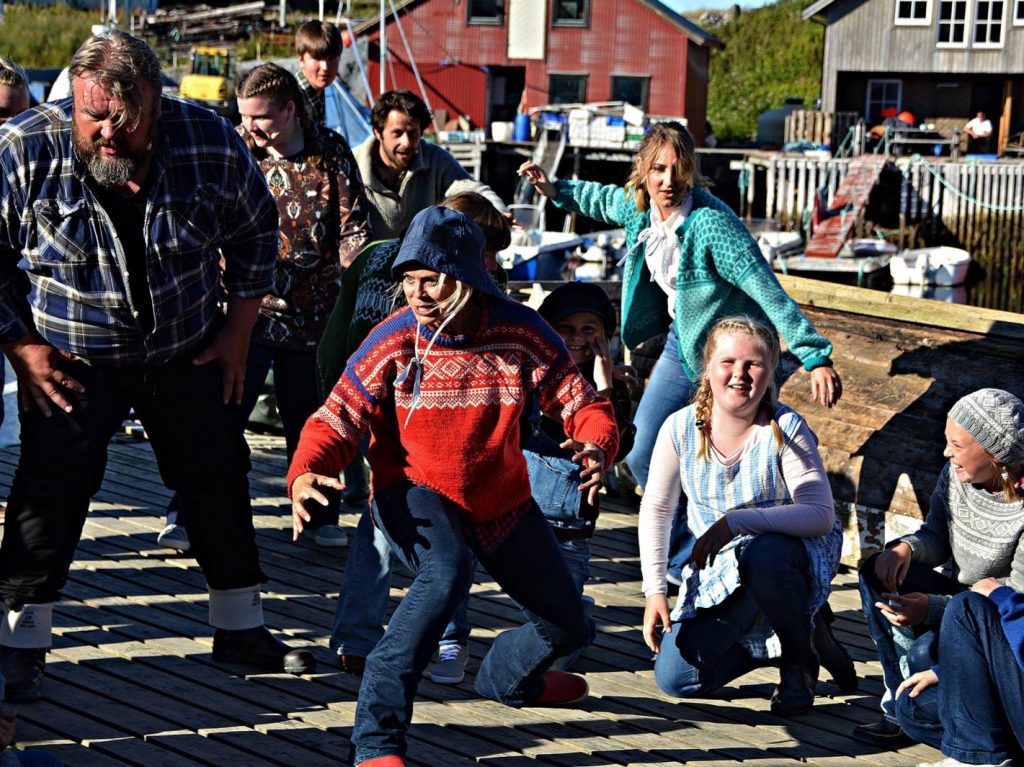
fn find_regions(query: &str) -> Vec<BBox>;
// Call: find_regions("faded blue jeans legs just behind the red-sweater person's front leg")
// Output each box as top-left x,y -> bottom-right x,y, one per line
331,506 -> 475,657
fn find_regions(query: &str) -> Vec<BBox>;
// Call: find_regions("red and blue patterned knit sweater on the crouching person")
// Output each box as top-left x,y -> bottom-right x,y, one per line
288,299 -> 618,524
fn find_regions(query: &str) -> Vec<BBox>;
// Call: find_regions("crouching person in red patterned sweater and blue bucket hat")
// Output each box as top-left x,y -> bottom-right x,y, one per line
288,203 -> 618,767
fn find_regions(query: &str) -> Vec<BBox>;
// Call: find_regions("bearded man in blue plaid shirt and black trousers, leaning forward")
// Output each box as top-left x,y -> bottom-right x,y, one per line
0,31 -> 314,701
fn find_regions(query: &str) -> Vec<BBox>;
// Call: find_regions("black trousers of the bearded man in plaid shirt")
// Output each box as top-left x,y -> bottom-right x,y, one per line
0,355 -> 266,607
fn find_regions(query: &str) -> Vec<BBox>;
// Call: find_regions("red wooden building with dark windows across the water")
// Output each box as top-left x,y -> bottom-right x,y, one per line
355,0 -> 722,142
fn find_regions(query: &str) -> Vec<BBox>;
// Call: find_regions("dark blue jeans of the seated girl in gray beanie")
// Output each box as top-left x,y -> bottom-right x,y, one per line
859,554 -> 964,723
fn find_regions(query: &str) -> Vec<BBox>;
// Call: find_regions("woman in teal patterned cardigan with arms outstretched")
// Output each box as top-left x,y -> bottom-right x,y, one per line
519,122 -> 842,574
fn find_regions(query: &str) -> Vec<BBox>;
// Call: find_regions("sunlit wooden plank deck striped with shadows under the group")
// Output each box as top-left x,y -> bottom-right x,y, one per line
0,435 -> 939,767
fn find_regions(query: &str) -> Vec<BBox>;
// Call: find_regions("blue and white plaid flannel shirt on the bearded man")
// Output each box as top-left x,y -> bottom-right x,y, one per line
0,97 -> 278,367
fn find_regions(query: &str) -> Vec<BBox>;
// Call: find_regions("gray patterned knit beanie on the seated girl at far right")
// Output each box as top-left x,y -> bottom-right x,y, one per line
949,389 -> 1024,466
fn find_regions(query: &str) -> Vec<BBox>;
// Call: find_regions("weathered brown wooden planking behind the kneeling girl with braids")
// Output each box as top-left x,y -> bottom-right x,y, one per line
779,275 -> 1024,562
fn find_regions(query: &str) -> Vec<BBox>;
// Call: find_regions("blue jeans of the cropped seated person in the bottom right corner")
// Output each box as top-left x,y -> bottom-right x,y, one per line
896,592 -> 1024,764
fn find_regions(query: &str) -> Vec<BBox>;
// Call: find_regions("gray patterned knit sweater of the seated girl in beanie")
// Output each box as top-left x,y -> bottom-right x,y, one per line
905,463 -> 1024,626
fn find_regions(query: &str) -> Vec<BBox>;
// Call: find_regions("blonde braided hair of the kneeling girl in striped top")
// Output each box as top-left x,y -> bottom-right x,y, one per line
693,315 -> 785,461
